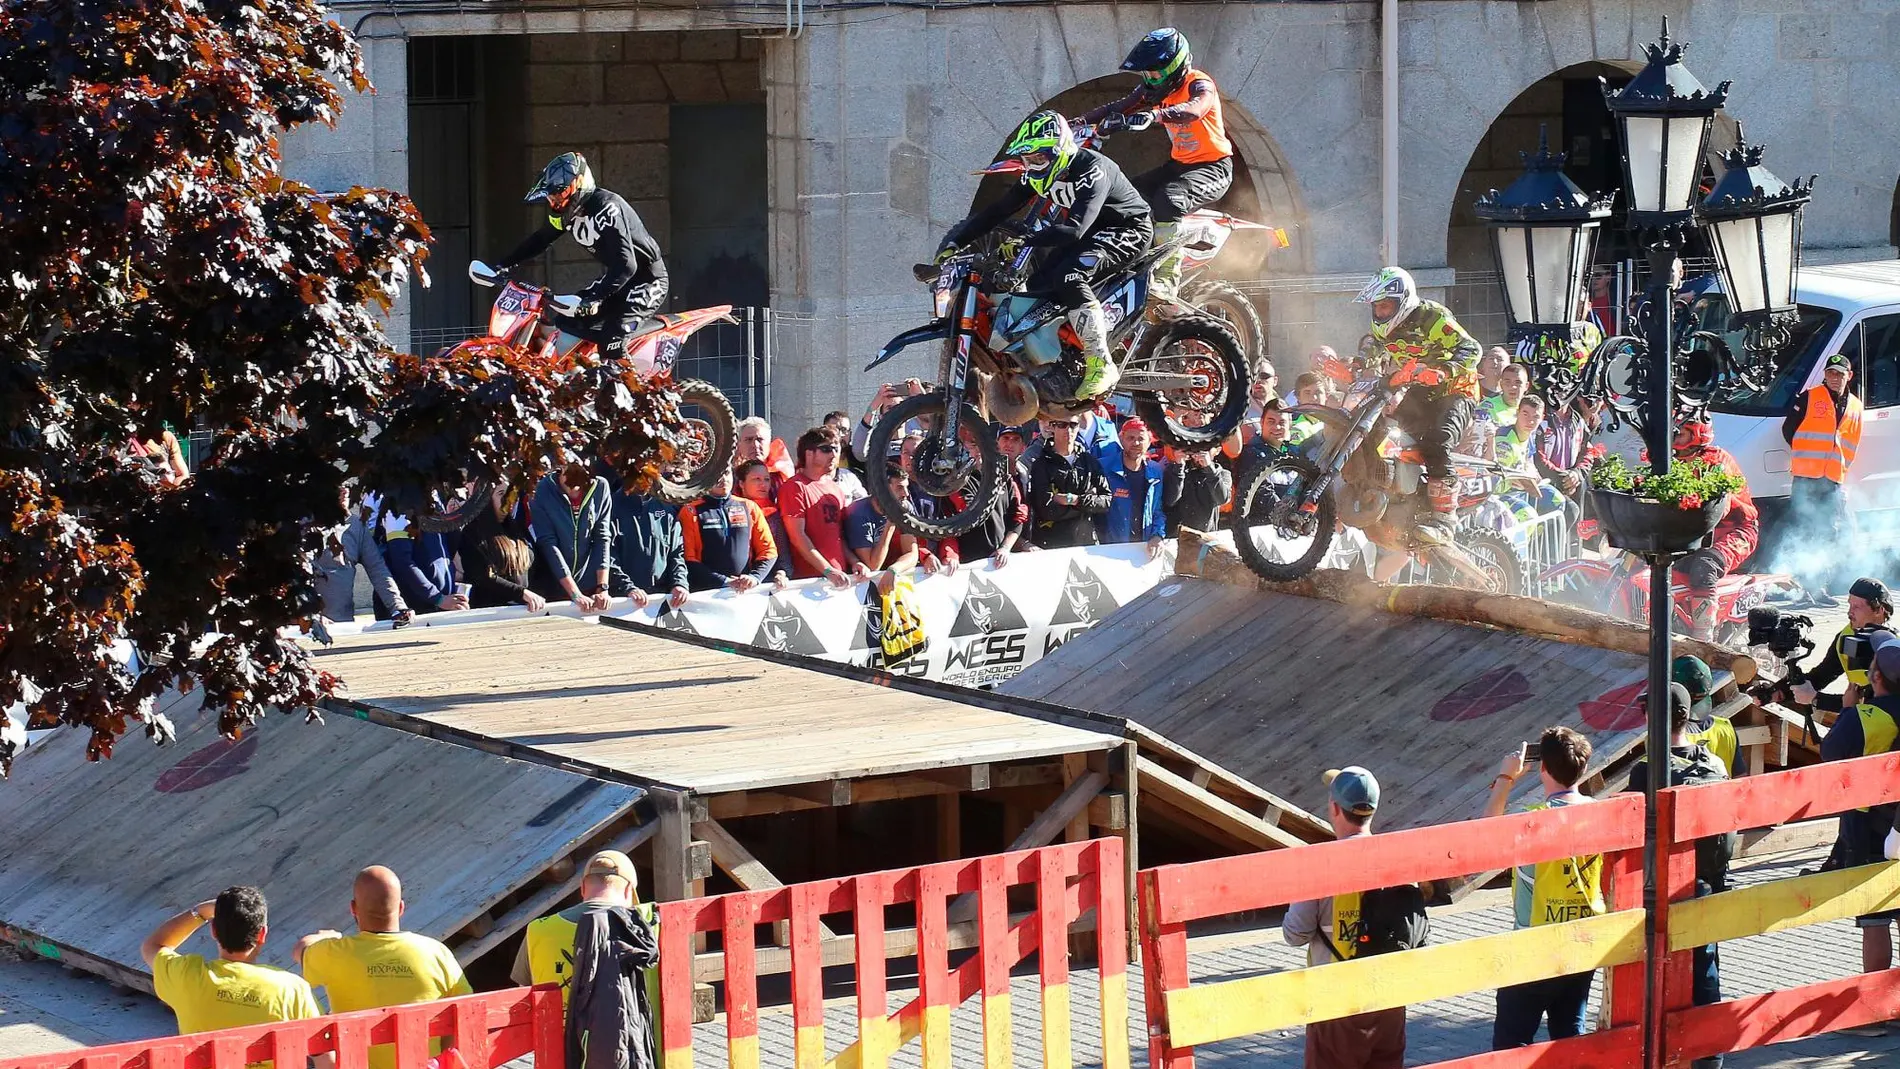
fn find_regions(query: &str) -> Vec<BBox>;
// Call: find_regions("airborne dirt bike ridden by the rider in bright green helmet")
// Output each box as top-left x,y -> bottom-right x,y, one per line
865,220 -> 1248,539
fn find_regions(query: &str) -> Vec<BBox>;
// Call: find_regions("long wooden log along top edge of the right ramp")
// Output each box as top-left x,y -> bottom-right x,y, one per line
1174,528 -> 1759,685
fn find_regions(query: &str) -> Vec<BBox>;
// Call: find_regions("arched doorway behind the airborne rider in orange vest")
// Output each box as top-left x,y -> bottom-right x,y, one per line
971,74 -> 1311,364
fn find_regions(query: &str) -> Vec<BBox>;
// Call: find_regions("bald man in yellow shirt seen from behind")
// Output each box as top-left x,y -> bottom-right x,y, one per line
291,864 -> 473,1069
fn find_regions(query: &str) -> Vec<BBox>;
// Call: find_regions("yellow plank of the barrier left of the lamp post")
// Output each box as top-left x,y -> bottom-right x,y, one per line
1167,910 -> 1644,1046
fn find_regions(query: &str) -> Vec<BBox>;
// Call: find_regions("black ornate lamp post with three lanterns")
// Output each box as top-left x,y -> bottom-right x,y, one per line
1476,17 -> 1813,1065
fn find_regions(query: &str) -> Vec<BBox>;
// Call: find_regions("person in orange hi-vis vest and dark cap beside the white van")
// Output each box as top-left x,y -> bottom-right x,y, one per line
1782,353 -> 1860,606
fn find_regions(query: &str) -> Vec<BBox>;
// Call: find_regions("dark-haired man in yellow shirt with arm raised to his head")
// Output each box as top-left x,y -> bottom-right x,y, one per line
139,887 -> 323,1065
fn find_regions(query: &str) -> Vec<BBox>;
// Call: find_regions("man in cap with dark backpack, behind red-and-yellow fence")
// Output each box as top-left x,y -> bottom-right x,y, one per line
1281,765 -> 1406,1069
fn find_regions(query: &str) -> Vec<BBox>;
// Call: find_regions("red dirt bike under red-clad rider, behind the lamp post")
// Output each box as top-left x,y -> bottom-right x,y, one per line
1541,554 -> 1807,649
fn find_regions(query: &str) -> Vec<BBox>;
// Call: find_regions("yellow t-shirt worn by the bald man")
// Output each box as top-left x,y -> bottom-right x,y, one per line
304,932 -> 473,1069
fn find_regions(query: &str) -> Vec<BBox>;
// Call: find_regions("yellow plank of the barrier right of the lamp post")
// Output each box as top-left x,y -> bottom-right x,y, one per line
1668,862 -> 1900,951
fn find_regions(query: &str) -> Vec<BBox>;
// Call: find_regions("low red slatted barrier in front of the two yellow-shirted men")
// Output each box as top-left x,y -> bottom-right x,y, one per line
0,984 -> 566,1069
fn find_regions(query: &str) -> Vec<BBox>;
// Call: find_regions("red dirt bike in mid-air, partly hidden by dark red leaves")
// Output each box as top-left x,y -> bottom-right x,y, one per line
420,260 -> 739,530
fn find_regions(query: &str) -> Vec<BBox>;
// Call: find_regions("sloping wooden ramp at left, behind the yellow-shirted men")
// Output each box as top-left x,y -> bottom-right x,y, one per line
0,693 -> 640,991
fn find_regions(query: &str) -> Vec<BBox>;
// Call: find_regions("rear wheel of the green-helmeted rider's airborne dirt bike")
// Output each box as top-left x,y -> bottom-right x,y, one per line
1129,309 -> 1250,450
